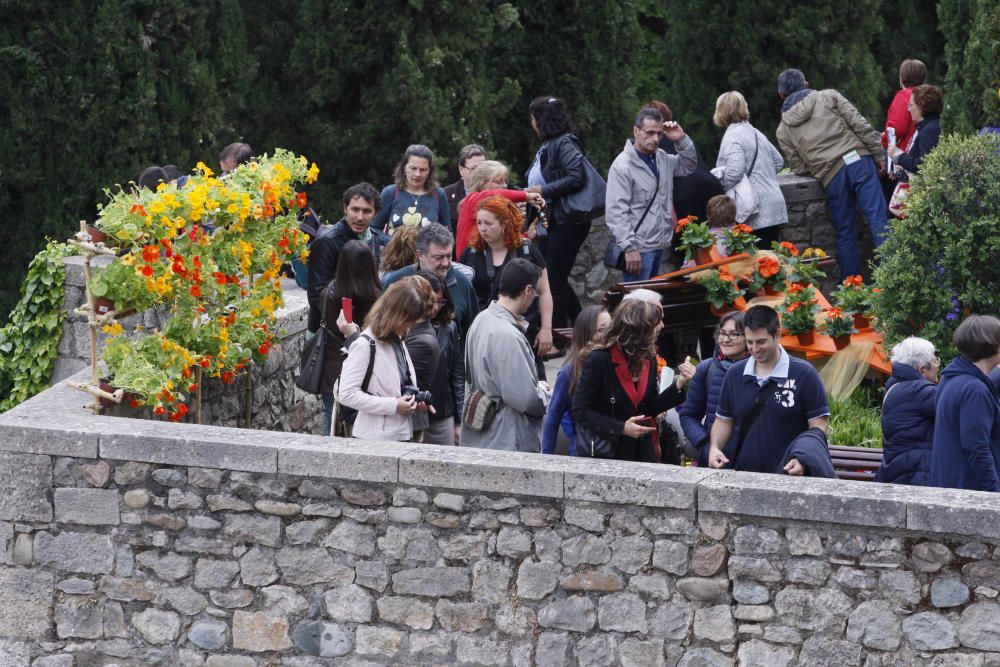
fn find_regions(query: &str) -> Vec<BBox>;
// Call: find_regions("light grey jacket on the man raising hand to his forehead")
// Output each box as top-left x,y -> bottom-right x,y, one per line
604,135 -> 698,252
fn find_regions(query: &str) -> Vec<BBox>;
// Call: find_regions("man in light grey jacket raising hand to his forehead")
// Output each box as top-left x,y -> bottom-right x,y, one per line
604,109 -> 698,282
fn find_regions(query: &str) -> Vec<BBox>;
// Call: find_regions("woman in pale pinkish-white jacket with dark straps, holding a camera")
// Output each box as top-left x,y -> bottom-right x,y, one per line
340,276 -> 431,442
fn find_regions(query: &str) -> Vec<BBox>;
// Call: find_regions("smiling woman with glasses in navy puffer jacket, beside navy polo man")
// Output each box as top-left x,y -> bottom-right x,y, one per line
677,312 -> 749,466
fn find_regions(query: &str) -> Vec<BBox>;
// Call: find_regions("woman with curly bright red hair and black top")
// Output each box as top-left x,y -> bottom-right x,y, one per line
458,196 -> 552,370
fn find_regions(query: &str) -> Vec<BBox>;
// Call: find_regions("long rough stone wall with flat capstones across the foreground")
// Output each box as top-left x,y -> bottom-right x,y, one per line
0,378 -> 1000,667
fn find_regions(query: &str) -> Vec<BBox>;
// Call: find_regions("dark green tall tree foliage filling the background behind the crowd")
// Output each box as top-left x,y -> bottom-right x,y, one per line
0,0 -> 988,326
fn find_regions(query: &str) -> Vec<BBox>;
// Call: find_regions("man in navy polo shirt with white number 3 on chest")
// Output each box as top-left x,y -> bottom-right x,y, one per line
708,306 -> 830,475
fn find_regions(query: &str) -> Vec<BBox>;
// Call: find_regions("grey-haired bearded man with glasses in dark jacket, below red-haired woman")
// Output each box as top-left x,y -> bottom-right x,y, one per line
382,222 -> 479,338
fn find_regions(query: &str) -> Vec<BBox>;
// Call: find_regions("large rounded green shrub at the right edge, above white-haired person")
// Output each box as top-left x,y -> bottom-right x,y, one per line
874,135 -> 1000,363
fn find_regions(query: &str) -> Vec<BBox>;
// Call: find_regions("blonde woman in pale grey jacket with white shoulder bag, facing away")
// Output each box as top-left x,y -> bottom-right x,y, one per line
712,90 -> 788,248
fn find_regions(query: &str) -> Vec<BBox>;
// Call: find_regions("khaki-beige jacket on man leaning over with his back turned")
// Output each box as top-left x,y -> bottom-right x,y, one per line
778,90 -> 882,187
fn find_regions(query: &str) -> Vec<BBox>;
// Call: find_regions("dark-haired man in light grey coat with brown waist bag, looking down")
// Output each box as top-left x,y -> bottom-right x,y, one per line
461,258 -> 545,452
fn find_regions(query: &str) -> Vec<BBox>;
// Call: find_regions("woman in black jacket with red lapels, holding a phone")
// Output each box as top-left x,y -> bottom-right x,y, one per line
573,300 -> 692,463
